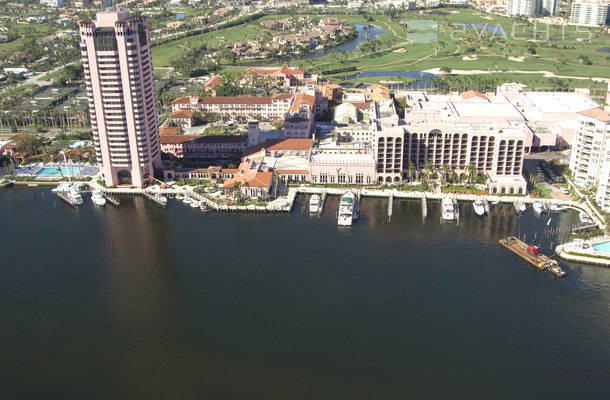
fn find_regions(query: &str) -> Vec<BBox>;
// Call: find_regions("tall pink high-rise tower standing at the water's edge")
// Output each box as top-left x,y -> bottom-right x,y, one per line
80,12 -> 161,187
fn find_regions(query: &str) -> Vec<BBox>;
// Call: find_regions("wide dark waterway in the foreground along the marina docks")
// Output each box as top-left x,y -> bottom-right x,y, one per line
0,189 -> 610,400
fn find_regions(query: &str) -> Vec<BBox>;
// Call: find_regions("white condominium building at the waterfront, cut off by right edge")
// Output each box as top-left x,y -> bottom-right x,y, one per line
570,108 -> 610,209
